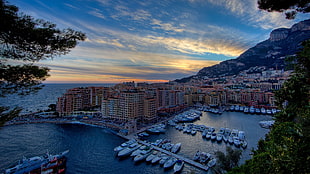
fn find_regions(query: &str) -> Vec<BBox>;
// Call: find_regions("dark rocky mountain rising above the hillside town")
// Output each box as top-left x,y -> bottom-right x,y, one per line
176,19 -> 310,81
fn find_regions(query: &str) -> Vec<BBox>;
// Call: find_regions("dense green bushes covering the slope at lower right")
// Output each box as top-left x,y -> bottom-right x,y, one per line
231,41 -> 310,173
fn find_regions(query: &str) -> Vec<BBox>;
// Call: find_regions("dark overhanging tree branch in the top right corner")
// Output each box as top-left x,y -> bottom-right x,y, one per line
258,0 -> 310,19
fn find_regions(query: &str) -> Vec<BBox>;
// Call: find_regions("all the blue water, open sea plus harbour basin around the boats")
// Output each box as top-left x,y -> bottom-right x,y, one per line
0,84 -> 272,174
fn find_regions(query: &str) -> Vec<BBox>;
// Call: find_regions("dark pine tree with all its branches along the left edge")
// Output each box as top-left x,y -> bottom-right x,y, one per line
0,0 -> 86,125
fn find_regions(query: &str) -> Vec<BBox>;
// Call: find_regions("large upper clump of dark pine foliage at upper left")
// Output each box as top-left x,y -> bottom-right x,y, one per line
0,0 -> 85,61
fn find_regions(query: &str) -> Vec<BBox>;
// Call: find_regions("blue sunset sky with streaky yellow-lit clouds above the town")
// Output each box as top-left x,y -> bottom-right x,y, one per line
8,0 -> 310,83
